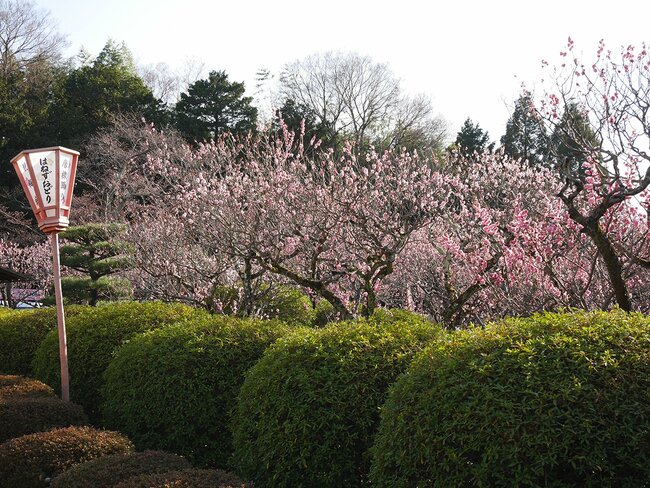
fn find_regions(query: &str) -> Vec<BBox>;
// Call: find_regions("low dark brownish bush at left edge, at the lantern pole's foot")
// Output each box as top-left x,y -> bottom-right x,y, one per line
0,396 -> 88,442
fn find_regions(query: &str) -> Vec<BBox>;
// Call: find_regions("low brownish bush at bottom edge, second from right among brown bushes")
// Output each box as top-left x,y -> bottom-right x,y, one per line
50,451 -> 191,488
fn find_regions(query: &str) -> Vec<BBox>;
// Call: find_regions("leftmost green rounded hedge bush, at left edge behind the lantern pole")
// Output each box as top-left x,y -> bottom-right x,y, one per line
0,305 -> 87,376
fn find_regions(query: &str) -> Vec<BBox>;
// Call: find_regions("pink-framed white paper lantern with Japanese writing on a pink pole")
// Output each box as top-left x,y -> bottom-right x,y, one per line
11,146 -> 79,401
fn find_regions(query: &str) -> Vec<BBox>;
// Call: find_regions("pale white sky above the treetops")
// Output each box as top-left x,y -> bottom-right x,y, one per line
35,0 -> 650,140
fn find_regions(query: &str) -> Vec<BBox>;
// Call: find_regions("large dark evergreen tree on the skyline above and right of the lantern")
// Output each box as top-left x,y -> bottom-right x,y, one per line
48,41 -> 166,145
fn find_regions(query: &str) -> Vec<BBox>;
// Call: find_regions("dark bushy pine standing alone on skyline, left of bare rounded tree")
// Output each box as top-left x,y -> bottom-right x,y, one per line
175,71 -> 257,142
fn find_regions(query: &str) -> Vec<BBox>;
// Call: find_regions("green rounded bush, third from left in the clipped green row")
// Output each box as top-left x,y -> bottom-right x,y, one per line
102,316 -> 293,467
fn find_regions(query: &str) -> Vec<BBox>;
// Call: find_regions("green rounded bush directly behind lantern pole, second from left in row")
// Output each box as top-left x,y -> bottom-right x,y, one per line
33,302 -> 208,421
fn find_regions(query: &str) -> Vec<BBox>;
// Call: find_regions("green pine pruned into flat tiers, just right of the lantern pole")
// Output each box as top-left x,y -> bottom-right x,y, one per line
61,224 -> 131,306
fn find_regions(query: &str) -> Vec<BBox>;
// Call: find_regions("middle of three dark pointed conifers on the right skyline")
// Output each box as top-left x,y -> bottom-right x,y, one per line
501,92 -> 550,166
